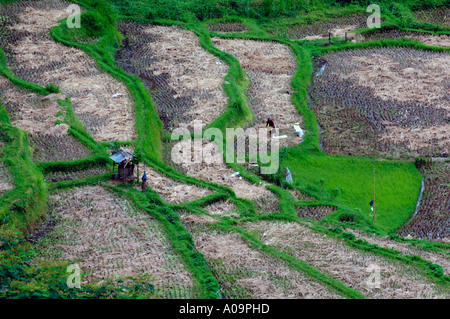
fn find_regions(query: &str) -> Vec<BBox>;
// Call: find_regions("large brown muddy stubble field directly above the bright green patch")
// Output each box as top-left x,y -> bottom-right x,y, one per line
310,48 -> 450,157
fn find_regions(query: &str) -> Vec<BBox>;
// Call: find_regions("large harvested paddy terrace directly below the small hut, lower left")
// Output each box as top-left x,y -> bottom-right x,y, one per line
33,186 -> 196,298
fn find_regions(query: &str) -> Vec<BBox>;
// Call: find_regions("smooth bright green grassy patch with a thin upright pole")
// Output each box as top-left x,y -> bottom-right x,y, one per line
284,152 -> 421,232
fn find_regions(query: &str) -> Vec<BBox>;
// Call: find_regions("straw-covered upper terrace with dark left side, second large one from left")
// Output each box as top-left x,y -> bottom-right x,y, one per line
116,23 -> 228,131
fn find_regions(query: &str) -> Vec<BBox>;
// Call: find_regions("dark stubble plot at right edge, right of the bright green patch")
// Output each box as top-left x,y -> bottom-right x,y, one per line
397,162 -> 450,242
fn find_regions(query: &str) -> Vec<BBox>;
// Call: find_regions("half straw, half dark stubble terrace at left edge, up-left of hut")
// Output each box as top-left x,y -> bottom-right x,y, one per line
0,77 -> 92,162
